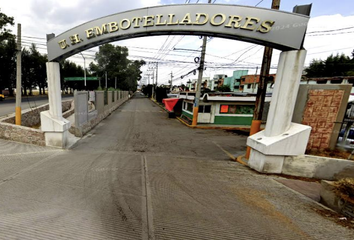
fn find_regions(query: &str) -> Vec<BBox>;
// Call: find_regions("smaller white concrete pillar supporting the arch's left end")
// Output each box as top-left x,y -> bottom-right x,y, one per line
41,62 -> 70,148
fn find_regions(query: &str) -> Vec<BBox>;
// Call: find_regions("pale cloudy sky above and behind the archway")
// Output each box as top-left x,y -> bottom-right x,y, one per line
0,0 -> 354,84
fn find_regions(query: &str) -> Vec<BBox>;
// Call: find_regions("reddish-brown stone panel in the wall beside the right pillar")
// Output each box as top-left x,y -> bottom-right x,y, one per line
302,89 -> 344,150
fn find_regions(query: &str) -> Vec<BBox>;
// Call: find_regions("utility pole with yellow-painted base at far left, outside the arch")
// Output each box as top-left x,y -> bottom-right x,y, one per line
15,23 -> 22,125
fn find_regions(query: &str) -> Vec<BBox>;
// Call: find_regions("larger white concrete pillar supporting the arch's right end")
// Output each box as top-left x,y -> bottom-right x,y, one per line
247,50 -> 311,173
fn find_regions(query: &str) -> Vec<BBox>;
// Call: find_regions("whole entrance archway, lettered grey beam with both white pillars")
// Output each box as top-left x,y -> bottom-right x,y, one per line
41,4 -> 310,172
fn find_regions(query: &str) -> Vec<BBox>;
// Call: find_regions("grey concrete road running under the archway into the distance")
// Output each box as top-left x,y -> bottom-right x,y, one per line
0,93 -> 354,240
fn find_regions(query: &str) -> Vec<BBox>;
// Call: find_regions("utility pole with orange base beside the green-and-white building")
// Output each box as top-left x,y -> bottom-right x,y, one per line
192,0 -> 211,126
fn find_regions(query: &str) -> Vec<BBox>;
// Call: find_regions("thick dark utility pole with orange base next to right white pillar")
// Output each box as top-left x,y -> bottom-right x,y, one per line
245,0 -> 280,159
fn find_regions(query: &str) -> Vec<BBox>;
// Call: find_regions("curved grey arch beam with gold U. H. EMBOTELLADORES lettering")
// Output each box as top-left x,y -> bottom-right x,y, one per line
47,4 -> 309,61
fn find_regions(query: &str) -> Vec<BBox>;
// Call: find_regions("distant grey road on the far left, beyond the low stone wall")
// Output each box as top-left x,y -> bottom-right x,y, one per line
0,95 -> 73,117
